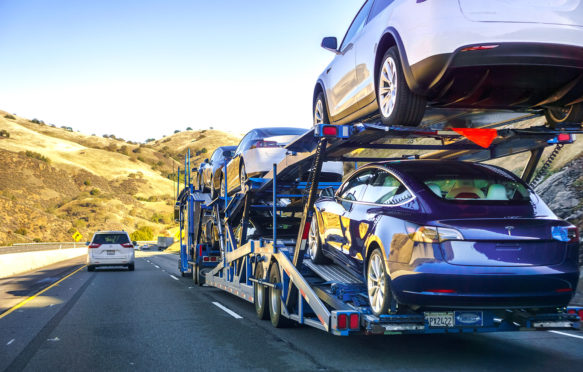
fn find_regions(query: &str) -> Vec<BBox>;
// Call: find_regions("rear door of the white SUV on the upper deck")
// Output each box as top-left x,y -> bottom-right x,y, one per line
353,0 -> 394,108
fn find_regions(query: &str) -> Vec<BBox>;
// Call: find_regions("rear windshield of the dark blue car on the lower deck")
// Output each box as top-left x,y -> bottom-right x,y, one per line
399,162 -> 530,202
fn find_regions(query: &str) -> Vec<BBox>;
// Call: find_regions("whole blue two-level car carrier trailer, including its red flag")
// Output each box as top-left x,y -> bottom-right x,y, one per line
175,113 -> 583,336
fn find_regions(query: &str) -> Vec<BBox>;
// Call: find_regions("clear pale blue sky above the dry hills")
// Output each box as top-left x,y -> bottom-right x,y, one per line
0,0 -> 363,141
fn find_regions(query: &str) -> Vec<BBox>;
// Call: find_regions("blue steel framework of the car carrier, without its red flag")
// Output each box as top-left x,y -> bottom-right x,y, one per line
176,119 -> 583,335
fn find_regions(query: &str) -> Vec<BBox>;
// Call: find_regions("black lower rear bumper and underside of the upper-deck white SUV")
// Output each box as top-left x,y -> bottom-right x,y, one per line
411,42 -> 583,109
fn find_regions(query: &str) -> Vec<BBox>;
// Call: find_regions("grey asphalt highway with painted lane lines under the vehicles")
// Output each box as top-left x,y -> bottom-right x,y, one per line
0,252 -> 583,371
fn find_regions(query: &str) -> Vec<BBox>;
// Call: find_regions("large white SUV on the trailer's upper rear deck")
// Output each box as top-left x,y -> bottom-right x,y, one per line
313,0 -> 583,125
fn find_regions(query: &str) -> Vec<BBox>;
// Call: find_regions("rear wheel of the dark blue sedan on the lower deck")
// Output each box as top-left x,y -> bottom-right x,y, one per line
366,248 -> 391,316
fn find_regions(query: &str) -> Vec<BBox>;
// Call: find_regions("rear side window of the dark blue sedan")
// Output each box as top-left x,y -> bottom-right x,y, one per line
362,171 -> 413,205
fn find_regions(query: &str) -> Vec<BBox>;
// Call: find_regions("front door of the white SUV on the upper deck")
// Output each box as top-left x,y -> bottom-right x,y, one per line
326,0 -> 372,121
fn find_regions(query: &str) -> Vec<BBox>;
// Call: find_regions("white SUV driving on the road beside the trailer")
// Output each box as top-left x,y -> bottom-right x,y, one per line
87,231 -> 137,271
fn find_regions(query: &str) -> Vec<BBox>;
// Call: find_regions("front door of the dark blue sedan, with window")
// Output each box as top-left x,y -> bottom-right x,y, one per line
321,169 -> 374,263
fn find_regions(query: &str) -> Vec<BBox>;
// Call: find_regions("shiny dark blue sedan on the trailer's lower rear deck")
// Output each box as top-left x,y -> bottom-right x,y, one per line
308,160 -> 579,315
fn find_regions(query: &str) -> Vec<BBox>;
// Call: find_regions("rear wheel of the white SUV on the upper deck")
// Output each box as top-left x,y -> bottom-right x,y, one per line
377,46 -> 427,127
